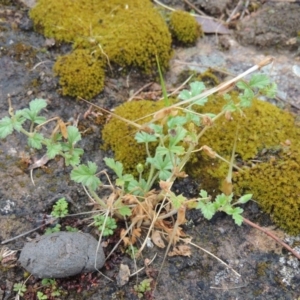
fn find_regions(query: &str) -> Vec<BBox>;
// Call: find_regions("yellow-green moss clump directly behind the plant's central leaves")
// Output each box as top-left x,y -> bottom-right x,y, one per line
102,100 -> 169,174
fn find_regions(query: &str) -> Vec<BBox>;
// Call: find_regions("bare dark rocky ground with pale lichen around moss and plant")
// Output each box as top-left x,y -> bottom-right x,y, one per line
0,0 -> 300,300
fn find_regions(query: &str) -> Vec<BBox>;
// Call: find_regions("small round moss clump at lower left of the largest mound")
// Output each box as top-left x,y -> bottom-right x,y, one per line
53,49 -> 105,99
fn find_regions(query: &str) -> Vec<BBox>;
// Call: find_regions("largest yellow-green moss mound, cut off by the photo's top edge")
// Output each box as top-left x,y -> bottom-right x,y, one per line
30,0 -> 172,85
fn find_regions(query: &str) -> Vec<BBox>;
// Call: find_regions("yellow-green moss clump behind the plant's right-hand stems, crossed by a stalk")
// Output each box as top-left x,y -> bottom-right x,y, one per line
187,93 -> 300,179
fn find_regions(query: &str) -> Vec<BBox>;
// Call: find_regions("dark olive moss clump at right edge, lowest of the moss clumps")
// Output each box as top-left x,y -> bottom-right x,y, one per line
234,143 -> 300,235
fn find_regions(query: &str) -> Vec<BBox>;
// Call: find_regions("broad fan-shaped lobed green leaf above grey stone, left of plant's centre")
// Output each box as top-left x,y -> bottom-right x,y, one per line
71,161 -> 101,191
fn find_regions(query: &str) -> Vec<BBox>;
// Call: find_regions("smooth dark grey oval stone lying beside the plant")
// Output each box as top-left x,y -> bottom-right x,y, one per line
19,231 -> 105,278
